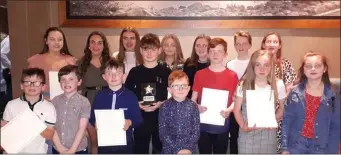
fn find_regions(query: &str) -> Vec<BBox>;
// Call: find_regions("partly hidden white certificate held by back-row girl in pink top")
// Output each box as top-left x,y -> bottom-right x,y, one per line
49,71 -> 63,100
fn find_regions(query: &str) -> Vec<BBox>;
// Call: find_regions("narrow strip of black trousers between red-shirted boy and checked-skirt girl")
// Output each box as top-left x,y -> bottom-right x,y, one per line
229,113 -> 239,154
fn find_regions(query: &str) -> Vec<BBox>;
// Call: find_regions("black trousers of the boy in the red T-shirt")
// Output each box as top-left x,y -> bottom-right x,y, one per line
198,132 -> 229,154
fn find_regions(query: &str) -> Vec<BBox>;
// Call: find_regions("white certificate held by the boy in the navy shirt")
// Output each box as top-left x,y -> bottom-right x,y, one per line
95,109 -> 127,146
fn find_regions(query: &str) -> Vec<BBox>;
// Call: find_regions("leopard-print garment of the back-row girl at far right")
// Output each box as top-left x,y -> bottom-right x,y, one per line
275,58 -> 296,153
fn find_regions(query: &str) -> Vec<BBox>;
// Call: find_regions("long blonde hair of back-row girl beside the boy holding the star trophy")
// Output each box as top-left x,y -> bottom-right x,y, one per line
160,34 -> 185,69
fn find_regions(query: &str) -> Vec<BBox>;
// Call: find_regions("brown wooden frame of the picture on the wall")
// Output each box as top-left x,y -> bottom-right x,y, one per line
58,0 -> 340,29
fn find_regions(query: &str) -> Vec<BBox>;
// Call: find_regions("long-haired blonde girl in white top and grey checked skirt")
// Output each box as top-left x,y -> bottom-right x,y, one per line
233,50 -> 286,154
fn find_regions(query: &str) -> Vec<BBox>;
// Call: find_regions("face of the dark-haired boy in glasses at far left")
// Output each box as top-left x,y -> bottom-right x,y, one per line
20,75 -> 45,96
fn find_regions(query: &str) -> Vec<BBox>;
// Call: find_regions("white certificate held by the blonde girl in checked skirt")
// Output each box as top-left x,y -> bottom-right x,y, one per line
246,89 -> 278,128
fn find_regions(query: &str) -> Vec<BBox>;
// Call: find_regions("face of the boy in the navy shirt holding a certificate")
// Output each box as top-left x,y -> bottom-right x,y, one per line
102,68 -> 124,87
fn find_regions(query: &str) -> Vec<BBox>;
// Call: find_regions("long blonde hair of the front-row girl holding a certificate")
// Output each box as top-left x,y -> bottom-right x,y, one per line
239,50 -> 278,104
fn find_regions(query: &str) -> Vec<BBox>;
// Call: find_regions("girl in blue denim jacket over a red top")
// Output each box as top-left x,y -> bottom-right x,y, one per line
281,52 -> 340,154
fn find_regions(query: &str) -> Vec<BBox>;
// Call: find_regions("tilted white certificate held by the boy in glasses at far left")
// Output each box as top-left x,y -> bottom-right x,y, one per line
1,108 -> 46,153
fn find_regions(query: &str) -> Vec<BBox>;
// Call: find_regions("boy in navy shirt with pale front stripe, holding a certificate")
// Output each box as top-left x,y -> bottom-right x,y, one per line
90,59 -> 143,154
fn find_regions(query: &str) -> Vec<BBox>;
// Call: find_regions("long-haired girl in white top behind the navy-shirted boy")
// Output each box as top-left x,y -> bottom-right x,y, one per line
113,27 -> 142,77
